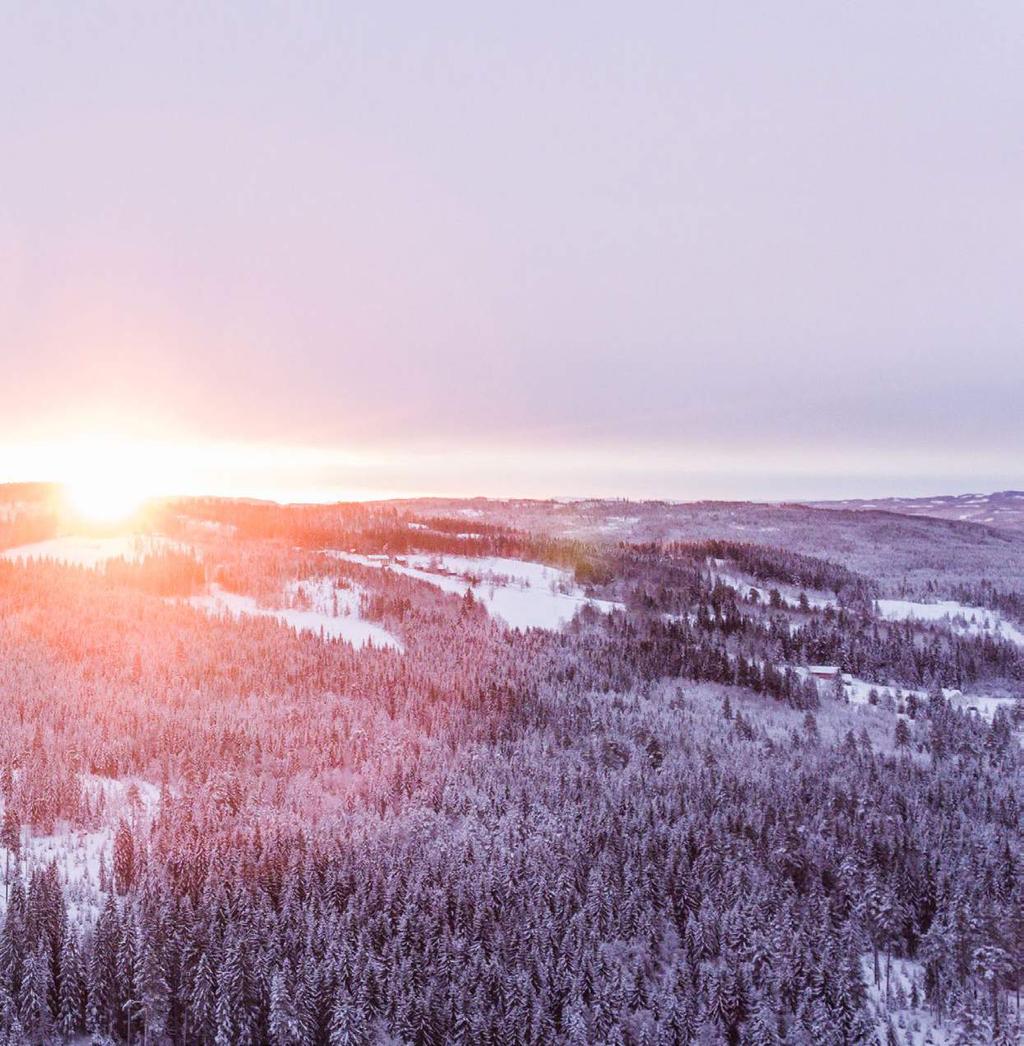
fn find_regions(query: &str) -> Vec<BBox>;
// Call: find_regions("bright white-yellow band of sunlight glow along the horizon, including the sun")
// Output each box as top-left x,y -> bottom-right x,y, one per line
0,432 -> 1012,502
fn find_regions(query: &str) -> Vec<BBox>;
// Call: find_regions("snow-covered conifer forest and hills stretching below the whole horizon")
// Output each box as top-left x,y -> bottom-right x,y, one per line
0,491 -> 1024,1046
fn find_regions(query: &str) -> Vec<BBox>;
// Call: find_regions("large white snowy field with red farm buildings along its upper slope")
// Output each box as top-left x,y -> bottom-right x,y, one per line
327,550 -> 619,629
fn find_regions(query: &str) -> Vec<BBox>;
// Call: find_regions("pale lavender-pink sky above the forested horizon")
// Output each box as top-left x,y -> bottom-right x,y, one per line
0,0 -> 1024,500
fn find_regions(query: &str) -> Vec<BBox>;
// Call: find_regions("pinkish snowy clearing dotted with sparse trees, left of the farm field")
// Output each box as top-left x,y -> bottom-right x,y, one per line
186,578 -> 403,651
